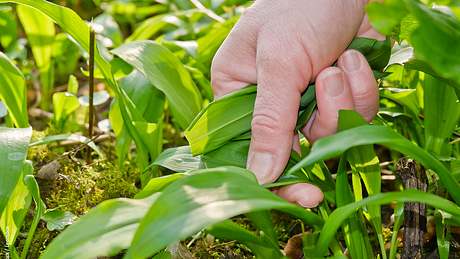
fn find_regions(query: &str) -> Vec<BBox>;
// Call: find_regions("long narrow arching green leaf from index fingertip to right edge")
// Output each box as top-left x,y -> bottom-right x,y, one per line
288,126 -> 460,204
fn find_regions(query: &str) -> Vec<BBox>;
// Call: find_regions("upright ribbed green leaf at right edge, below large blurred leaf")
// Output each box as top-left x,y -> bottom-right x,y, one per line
423,75 -> 460,157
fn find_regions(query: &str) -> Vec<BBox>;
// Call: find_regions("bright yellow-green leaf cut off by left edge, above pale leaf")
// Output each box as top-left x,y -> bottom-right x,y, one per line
0,52 -> 29,128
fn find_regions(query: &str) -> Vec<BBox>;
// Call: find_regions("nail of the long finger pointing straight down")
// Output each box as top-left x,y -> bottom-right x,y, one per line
248,152 -> 273,184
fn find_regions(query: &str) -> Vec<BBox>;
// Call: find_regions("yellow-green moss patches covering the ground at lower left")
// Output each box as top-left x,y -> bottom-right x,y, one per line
21,140 -> 139,258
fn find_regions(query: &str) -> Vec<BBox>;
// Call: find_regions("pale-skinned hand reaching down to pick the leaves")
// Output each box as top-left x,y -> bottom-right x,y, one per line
211,0 -> 382,208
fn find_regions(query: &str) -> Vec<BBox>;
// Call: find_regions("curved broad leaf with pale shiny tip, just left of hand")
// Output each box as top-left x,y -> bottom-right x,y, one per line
112,41 -> 202,128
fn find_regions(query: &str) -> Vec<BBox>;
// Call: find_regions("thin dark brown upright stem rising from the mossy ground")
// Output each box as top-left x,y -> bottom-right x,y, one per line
86,28 -> 96,163
